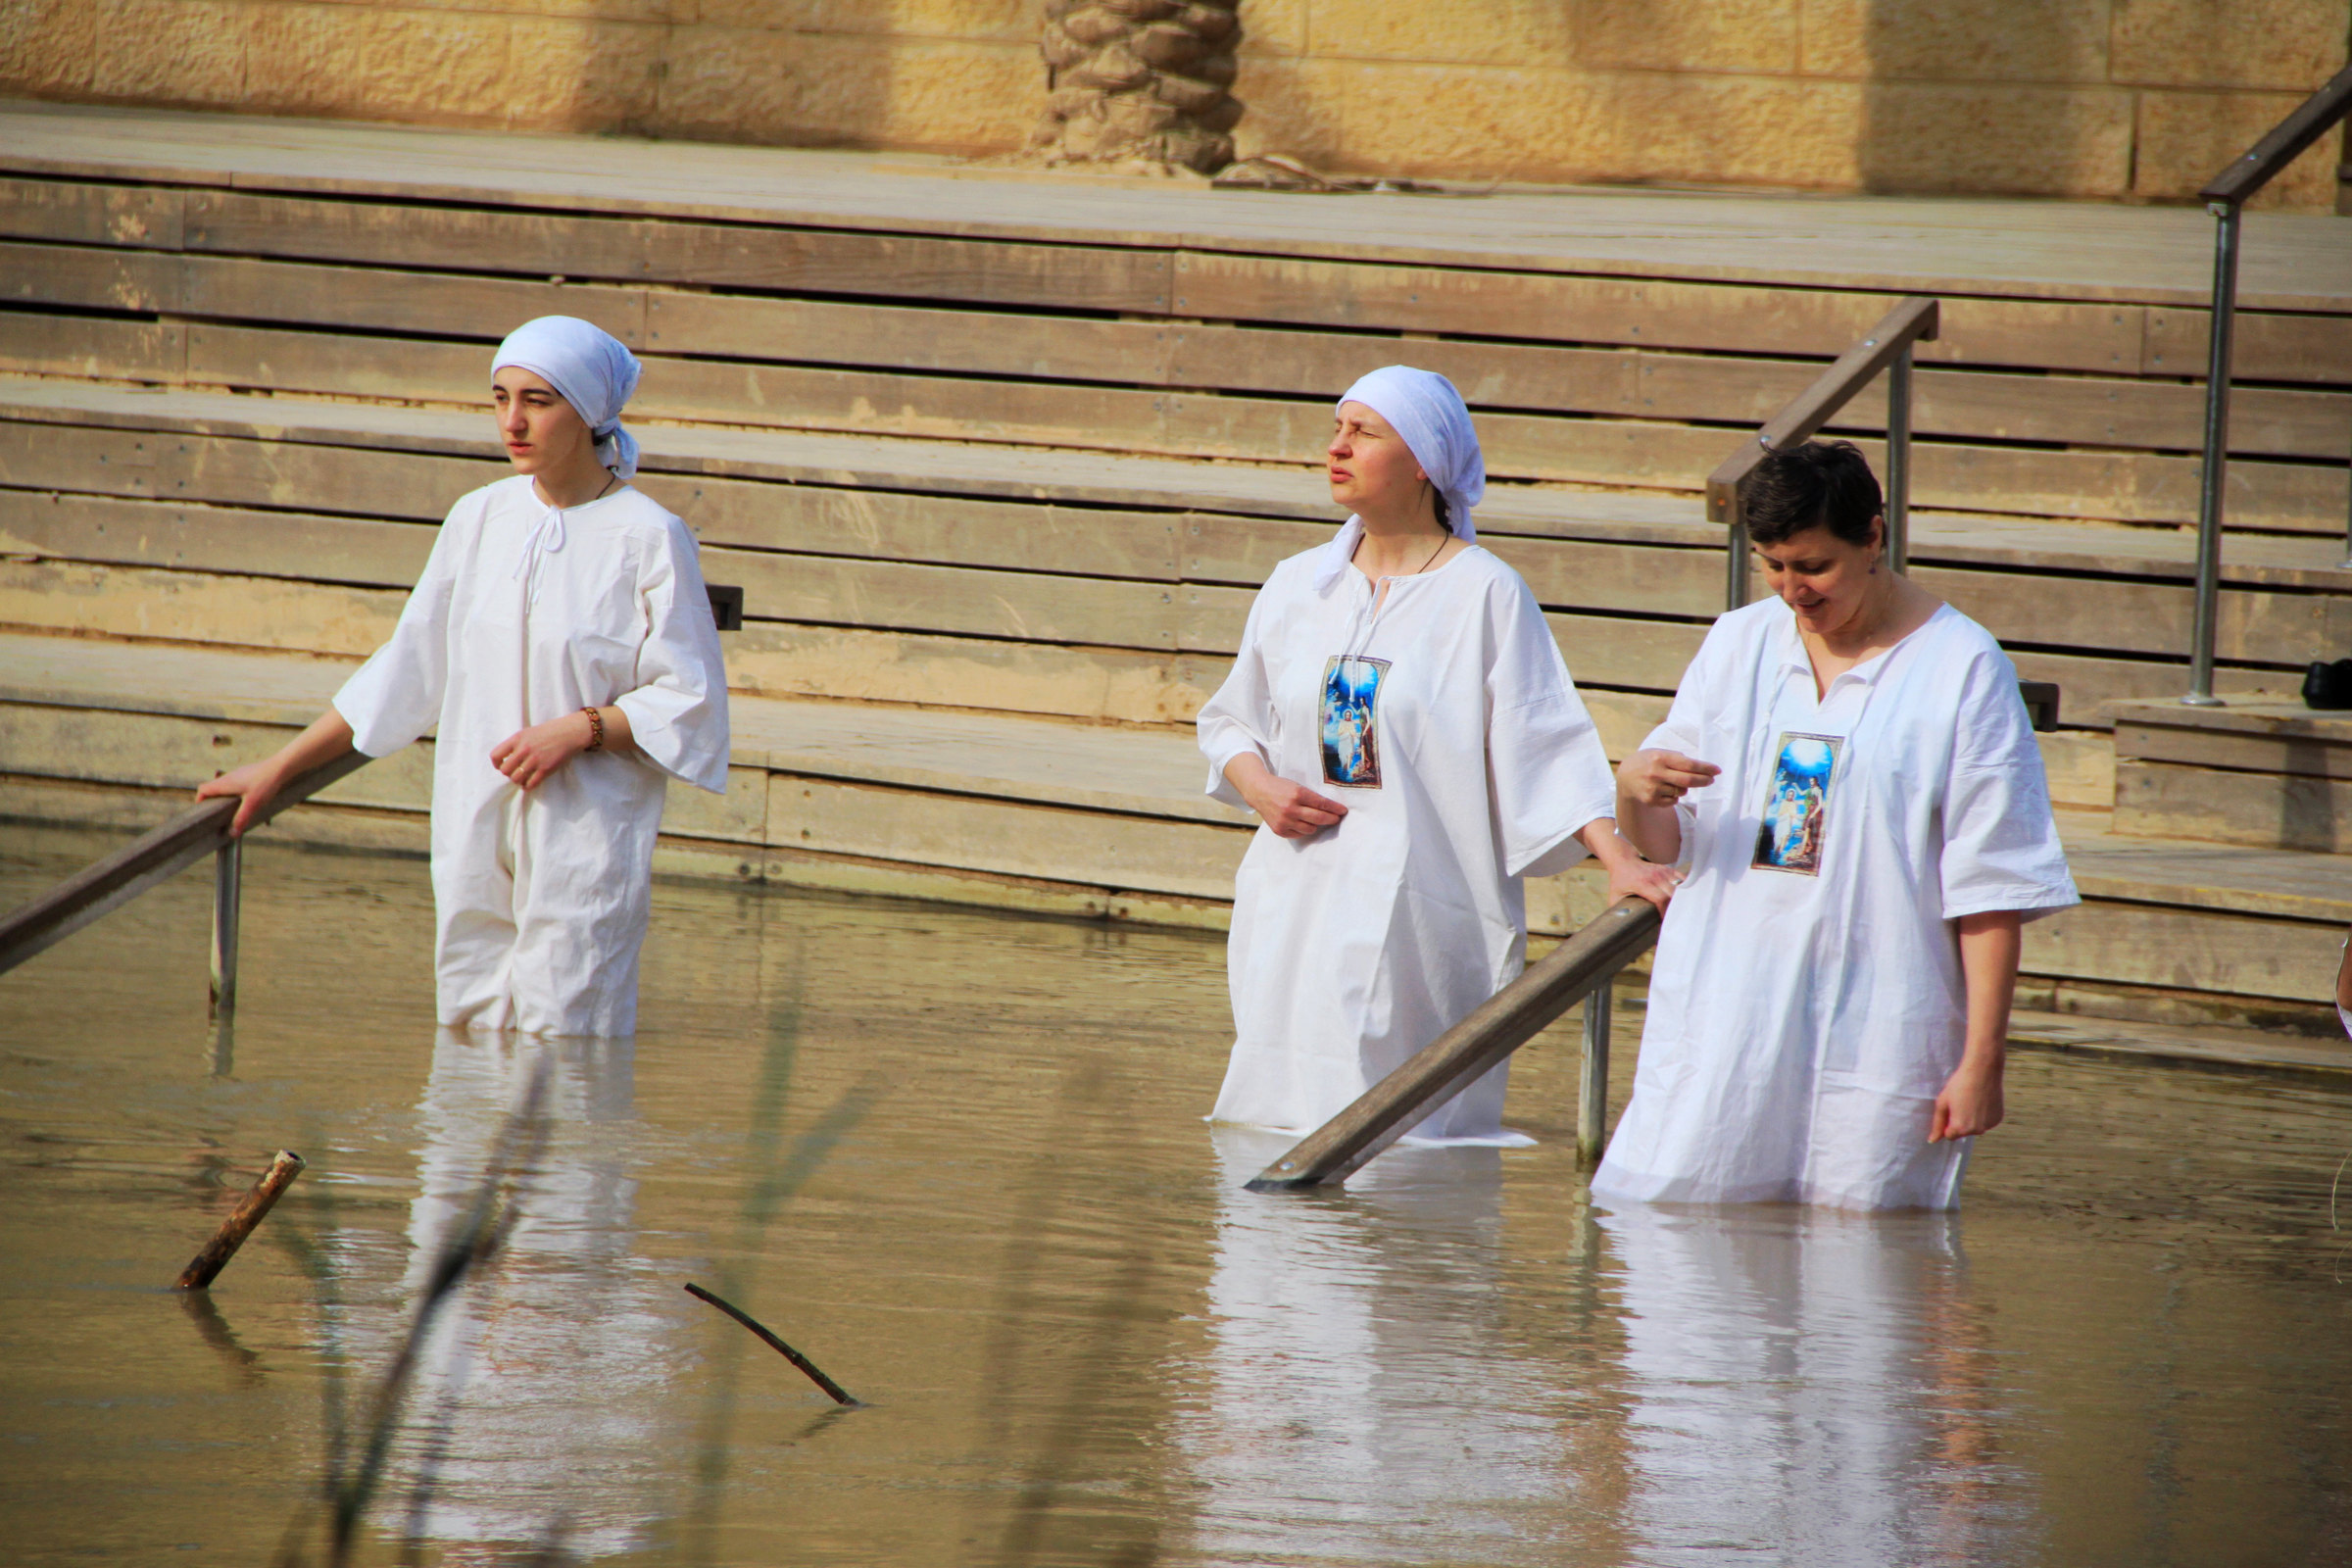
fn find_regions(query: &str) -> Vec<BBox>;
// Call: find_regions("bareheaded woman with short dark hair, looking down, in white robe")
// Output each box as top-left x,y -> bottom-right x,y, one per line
1592,442 -> 2077,1208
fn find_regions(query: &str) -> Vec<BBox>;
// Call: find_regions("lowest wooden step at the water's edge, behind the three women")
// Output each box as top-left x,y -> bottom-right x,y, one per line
0,635 -> 2352,1034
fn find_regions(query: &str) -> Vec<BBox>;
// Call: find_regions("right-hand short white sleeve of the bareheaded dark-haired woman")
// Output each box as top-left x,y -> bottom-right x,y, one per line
1940,647 -> 2082,919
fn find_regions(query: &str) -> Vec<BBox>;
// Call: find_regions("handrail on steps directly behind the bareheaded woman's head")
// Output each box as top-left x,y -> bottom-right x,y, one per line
1707,294 -> 1942,609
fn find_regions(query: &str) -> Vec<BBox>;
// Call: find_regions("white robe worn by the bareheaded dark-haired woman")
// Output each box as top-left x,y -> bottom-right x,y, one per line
1592,600 -> 2077,1208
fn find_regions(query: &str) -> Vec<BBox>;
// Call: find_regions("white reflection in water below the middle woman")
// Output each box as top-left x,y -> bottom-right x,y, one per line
1188,1126 -> 1576,1563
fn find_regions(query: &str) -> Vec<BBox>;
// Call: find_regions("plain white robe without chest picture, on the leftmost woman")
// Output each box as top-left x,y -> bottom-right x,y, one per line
334,475 -> 727,1034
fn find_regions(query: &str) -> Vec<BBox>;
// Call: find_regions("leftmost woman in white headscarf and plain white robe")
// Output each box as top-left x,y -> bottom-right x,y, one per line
198,315 -> 727,1034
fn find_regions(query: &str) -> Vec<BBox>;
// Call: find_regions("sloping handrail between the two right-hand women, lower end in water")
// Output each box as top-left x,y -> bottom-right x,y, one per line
1249,898 -> 1658,1192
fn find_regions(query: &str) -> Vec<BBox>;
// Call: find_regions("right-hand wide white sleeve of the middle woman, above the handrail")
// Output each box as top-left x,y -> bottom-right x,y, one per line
1487,573 -> 1616,877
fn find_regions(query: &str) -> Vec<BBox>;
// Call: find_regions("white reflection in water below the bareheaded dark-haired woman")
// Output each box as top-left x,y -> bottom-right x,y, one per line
1599,1203 -> 2033,1563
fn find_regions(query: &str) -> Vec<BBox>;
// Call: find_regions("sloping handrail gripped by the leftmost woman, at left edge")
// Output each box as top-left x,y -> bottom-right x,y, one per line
0,753 -> 369,1018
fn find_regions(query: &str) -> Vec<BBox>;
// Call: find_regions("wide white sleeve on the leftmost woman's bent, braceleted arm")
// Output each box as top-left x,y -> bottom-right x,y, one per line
613,517 -> 729,795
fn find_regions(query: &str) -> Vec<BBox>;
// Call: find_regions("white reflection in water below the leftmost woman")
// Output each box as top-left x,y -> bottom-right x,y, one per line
383,1030 -> 680,1556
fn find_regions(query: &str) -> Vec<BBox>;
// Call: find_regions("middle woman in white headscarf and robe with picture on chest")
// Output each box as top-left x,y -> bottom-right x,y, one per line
1200,365 -> 1675,1143
